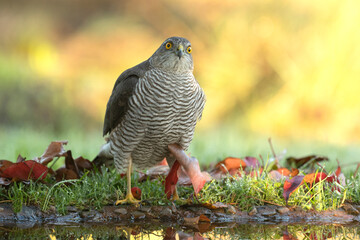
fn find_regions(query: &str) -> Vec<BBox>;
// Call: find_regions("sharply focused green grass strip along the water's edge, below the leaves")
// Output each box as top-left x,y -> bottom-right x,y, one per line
0,165 -> 360,214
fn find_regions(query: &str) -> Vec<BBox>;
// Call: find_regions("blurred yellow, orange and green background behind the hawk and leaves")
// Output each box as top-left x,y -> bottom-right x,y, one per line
0,0 -> 360,171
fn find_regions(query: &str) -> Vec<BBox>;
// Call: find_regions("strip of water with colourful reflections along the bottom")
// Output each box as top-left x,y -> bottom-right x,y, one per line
0,223 -> 360,240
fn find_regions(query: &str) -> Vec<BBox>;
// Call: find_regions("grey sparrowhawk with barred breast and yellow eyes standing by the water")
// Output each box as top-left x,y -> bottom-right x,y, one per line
97,37 -> 205,204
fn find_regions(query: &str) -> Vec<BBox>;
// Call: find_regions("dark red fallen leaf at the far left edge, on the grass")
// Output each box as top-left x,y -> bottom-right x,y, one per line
1,160 -> 49,180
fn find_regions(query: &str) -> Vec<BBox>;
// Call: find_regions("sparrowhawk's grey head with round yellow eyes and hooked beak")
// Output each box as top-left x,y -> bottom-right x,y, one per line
149,37 -> 194,72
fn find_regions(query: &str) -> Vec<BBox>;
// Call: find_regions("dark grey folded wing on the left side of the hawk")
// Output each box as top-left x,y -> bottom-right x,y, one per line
103,61 -> 150,136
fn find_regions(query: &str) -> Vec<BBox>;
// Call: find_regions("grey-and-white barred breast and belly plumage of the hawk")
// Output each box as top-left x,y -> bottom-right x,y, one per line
110,69 -> 205,172
